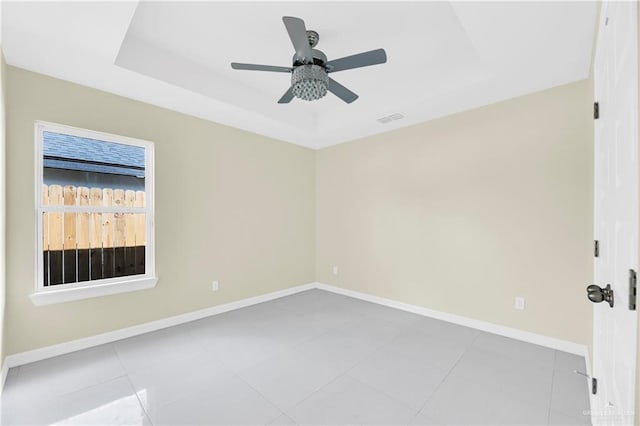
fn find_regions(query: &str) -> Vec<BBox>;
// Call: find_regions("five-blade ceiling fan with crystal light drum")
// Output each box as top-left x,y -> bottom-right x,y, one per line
231,16 -> 387,104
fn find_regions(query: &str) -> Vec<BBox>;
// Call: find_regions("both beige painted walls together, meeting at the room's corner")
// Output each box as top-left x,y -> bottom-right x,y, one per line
6,67 -> 593,360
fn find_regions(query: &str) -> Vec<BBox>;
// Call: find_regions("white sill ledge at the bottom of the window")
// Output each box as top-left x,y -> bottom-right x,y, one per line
29,277 -> 158,306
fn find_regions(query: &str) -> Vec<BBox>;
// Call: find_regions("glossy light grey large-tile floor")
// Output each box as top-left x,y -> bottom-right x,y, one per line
1,290 -> 589,425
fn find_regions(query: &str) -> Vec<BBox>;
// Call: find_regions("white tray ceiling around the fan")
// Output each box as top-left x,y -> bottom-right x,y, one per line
2,1 -> 597,148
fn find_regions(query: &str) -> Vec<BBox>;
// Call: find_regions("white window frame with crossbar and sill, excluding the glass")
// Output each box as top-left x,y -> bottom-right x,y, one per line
29,121 -> 158,305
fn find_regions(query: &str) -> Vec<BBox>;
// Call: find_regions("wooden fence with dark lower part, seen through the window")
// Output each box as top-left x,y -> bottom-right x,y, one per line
42,185 -> 146,286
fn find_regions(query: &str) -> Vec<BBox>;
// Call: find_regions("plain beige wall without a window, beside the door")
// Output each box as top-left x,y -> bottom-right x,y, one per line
316,81 -> 593,344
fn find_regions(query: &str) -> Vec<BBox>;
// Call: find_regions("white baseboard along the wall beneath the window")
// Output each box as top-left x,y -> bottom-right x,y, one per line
2,283 -> 316,372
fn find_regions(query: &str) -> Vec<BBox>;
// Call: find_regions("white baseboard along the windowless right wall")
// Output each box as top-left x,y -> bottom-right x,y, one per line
315,283 -> 589,359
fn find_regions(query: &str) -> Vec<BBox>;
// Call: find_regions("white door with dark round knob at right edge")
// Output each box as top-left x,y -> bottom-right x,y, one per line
592,1 -> 639,424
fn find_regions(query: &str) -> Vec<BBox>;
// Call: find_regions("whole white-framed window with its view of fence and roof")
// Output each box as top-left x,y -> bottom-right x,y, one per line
31,122 -> 157,305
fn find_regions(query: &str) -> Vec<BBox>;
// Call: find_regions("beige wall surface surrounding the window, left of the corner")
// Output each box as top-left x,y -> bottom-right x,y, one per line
6,67 -> 315,354
